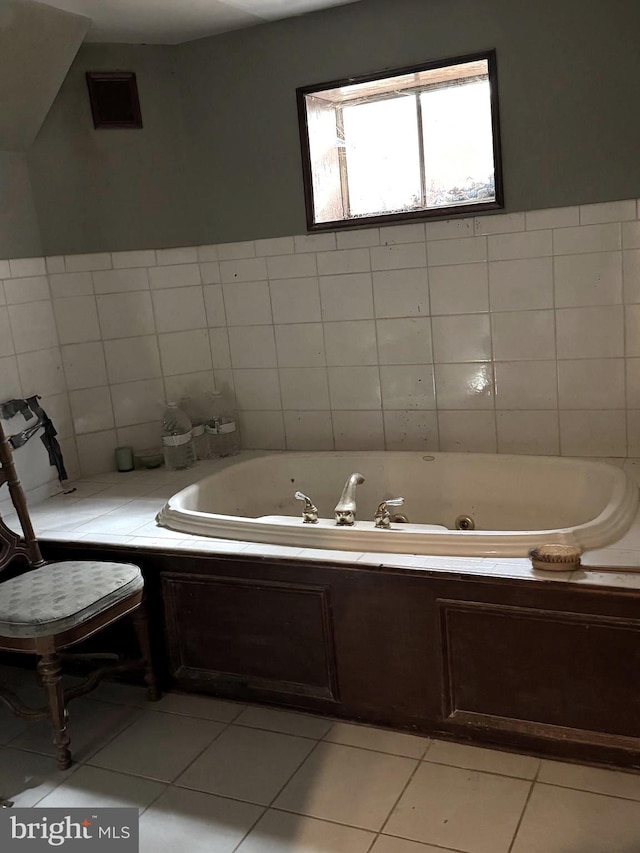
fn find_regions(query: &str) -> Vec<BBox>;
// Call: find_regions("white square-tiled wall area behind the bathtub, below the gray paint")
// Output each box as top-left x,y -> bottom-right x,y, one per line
0,200 -> 640,480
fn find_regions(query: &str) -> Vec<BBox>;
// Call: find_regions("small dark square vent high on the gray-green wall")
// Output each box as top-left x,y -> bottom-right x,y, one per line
87,71 -> 142,128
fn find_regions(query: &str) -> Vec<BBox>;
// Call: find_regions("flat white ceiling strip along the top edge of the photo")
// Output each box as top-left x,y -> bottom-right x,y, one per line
25,0 -> 357,44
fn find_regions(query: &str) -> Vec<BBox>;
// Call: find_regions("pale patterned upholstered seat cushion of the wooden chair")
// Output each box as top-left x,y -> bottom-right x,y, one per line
0,560 -> 144,637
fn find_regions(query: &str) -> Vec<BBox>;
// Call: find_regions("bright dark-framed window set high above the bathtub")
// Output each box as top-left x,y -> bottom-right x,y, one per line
297,51 -> 503,230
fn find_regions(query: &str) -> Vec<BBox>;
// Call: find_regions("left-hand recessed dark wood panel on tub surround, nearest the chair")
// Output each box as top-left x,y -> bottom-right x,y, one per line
162,572 -> 338,701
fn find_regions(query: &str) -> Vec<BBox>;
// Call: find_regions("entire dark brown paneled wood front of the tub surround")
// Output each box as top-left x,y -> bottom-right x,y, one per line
38,542 -> 640,767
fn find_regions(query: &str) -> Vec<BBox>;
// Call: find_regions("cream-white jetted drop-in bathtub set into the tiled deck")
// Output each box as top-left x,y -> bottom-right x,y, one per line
158,452 -> 638,557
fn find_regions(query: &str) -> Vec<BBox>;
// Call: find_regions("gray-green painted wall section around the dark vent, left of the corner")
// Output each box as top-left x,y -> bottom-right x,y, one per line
29,44 -> 198,254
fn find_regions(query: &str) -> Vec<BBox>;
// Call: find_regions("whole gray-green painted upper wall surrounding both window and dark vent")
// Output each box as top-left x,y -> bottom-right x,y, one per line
22,0 -> 640,253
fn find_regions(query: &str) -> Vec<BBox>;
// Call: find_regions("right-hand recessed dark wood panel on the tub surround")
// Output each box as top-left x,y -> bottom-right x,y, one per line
438,600 -> 640,743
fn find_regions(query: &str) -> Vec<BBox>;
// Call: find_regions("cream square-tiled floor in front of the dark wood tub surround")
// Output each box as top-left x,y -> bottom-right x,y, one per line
0,669 -> 640,853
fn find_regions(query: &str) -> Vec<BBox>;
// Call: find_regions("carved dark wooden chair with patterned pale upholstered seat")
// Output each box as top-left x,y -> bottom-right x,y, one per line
0,424 -> 159,770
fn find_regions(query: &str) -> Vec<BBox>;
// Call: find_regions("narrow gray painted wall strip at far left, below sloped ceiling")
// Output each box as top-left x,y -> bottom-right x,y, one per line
0,151 -> 42,258
